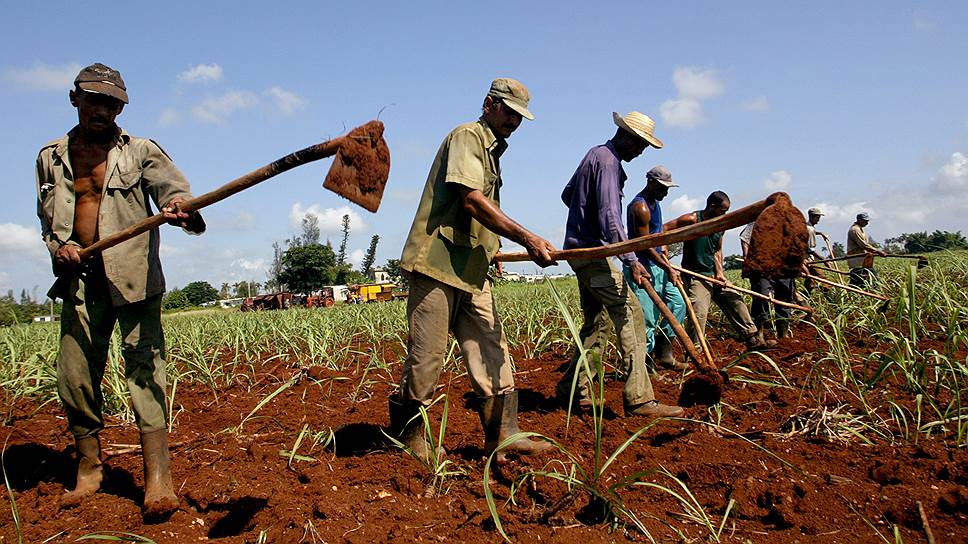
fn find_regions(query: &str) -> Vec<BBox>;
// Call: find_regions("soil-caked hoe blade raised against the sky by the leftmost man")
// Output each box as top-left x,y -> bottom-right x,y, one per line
323,121 -> 390,212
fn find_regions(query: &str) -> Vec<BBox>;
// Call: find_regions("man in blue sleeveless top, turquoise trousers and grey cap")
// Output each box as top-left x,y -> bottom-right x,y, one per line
623,166 -> 687,370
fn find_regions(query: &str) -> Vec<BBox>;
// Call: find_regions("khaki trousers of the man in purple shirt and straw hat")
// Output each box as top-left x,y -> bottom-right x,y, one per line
558,259 -> 655,406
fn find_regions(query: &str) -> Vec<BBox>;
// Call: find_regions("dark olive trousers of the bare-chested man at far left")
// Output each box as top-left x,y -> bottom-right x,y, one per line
57,274 -> 168,437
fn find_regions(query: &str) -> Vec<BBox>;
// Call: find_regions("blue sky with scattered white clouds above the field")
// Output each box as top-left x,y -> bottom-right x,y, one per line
0,2 -> 968,295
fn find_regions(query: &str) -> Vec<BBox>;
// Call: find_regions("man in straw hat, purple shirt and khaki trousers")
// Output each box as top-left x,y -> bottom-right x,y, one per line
556,111 -> 682,417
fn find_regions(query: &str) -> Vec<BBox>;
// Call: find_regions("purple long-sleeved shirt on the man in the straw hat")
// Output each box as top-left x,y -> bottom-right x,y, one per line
561,140 -> 638,265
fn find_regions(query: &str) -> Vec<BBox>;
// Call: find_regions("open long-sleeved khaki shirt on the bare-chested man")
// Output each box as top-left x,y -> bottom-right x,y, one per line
37,127 -> 192,306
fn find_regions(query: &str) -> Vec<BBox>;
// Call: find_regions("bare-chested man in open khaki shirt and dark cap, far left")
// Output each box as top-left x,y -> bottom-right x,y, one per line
37,63 -> 205,516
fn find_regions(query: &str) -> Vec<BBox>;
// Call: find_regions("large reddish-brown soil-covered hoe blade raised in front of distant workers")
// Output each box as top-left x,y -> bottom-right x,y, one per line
743,193 -> 807,279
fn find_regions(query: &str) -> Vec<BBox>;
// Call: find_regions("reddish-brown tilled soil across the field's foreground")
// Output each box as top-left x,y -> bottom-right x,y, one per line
0,325 -> 968,544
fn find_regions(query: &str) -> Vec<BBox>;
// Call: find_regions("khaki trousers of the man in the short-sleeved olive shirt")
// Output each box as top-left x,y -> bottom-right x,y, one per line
400,272 -> 514,405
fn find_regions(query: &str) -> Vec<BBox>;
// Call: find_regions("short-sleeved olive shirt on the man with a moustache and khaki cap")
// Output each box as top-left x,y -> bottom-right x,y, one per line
400,118 -> 507,294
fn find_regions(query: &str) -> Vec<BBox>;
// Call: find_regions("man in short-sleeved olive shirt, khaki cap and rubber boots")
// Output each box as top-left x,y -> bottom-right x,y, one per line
389,78 -> 555,459
